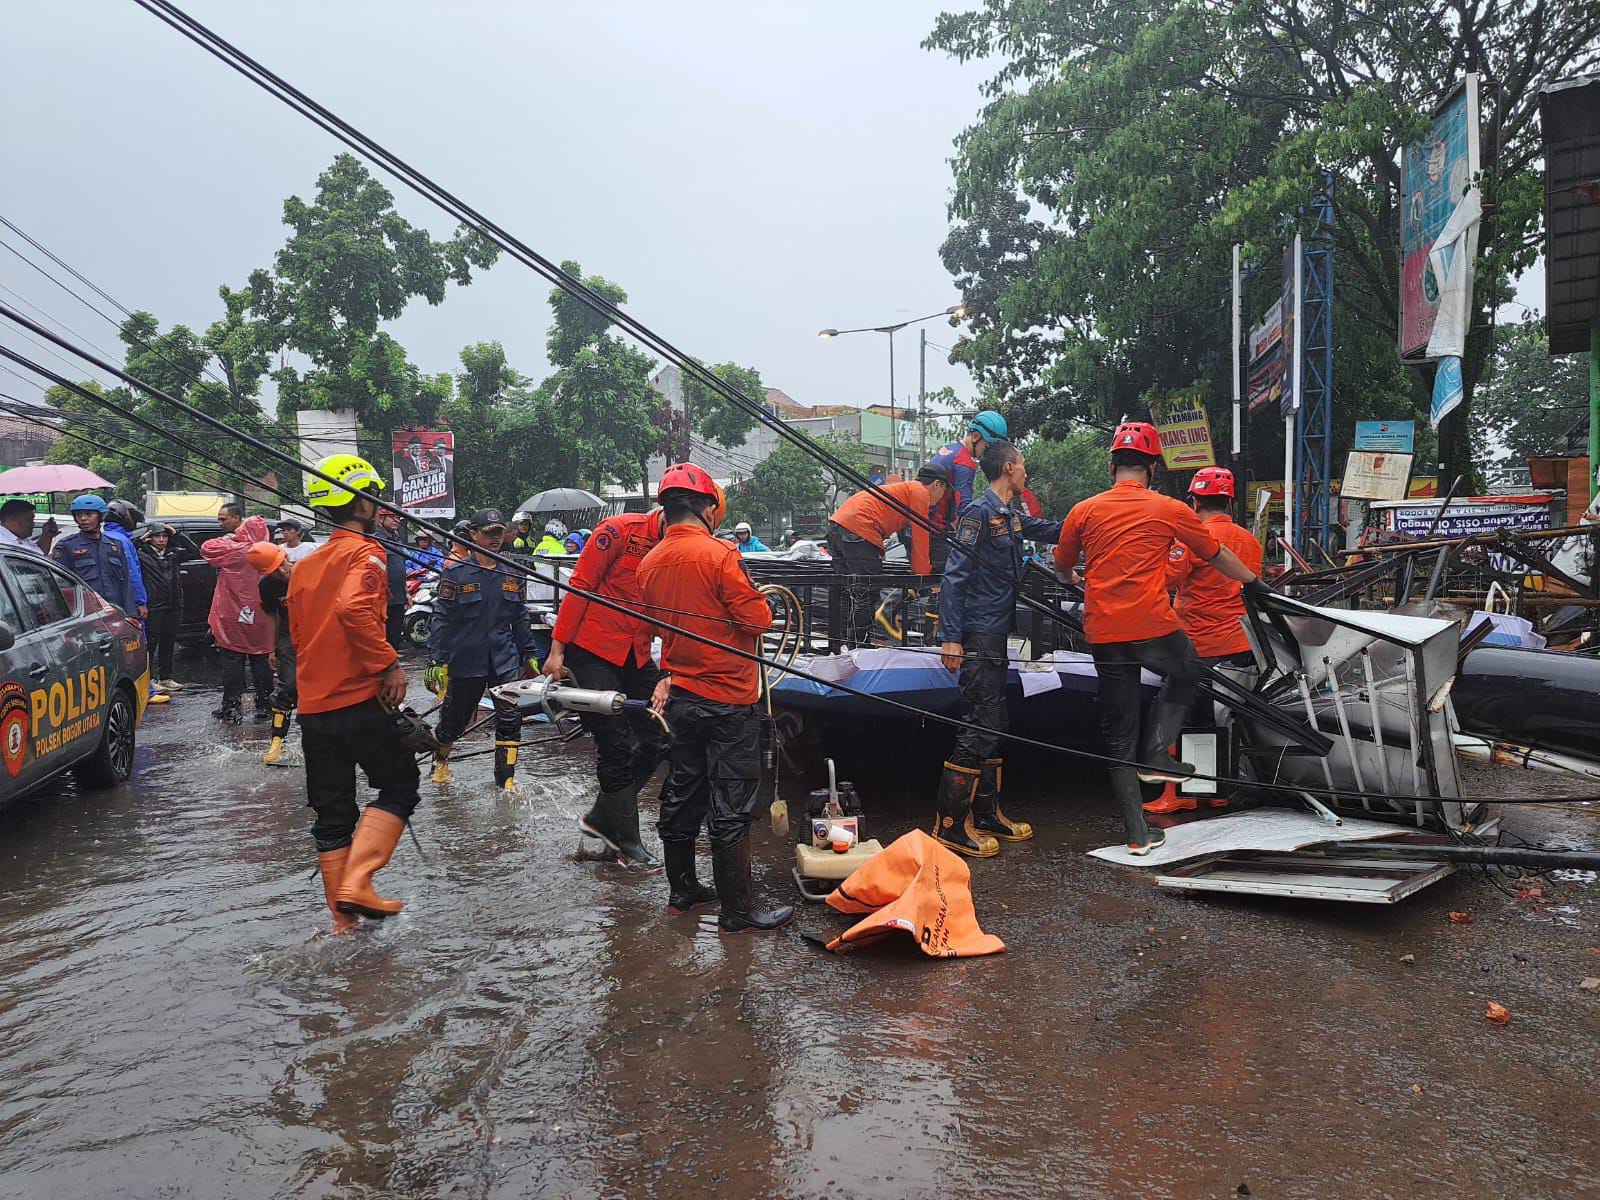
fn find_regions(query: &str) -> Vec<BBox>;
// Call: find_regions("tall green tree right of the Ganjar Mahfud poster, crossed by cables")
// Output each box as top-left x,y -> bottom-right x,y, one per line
530,262 -> 661,490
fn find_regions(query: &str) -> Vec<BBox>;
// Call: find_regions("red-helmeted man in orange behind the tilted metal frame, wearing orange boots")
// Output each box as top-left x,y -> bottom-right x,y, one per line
1144,467 -> 1261,813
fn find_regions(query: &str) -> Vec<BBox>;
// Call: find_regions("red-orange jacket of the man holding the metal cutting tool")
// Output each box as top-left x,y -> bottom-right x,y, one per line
550,509 -> 672,666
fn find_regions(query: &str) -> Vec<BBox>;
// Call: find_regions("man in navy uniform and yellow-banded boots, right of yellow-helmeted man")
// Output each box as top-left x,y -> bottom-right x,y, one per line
422,509 -> 538,794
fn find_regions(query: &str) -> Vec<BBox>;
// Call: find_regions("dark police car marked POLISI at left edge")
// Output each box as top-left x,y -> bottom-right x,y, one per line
0,547 -> 150,803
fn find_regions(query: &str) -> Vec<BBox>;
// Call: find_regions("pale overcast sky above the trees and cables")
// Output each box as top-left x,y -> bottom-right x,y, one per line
0,0 -> 986,419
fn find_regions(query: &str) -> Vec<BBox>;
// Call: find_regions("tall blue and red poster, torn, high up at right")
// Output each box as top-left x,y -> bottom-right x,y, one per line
1400,75 -> 1478,362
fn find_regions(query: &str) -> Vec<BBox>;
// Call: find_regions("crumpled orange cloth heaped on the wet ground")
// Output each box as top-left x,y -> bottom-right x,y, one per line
827,829 -> 1005,958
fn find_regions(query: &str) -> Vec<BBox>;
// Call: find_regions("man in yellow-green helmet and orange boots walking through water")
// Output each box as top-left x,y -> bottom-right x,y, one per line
285,454 -> 421,928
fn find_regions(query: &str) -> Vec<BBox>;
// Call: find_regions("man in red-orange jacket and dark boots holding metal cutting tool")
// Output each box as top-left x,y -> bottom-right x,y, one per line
544,509 -> 672,869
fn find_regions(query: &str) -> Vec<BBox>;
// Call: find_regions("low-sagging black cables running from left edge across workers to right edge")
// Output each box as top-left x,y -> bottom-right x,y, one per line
0,321 -> 1600,805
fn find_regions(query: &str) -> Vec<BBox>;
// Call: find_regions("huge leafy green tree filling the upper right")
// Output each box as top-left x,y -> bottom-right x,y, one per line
925,0 -> 1600,483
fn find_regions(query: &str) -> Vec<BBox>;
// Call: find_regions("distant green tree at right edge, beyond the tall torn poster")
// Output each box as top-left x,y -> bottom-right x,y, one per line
1472,320 -> 1589,462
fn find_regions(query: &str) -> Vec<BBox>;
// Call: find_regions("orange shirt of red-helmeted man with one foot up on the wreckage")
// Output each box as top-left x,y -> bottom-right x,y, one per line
1056,480 -> 1222,645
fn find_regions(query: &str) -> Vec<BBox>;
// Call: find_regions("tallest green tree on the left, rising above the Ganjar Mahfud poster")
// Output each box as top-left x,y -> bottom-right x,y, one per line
248,154 -> 499,441
